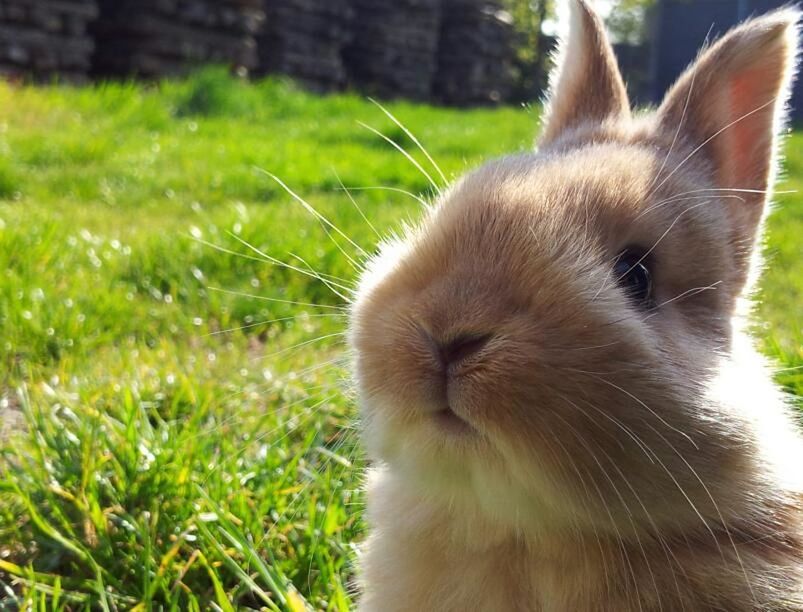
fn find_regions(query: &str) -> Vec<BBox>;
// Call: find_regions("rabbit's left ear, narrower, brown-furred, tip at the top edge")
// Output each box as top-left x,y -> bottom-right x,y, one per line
539,0 -> 630,145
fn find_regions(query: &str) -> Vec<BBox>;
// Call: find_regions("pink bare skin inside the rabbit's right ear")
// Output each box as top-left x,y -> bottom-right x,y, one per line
723,68 -> 773,189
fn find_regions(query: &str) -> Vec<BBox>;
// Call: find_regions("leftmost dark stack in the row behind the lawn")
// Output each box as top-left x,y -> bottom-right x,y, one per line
0,0 -> 98,80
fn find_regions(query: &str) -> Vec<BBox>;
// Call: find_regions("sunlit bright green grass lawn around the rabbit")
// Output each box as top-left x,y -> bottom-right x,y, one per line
0,71 -> 803,610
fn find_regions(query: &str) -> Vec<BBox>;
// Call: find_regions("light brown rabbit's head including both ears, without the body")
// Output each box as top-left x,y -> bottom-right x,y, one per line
350,0 -> 798,532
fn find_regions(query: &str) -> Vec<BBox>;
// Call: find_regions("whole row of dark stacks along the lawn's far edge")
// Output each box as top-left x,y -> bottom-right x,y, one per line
0,0 -> 512,104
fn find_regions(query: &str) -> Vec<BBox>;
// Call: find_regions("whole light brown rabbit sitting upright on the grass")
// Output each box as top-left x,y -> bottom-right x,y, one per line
348,0 -> 803,612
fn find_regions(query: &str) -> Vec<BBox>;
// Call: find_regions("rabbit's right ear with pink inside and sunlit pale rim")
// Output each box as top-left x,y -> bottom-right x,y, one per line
657,8 -> 800,246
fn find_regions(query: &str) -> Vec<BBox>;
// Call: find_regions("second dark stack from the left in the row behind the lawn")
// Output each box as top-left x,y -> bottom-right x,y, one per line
92,0 -> 264,77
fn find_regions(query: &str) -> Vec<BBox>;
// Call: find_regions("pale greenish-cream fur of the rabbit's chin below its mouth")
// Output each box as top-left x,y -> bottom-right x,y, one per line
363,413 -> 594,536
